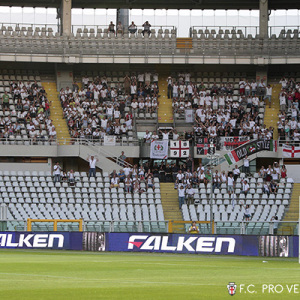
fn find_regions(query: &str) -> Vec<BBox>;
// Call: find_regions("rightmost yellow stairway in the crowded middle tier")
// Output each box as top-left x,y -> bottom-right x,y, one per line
264,84 -> 281,140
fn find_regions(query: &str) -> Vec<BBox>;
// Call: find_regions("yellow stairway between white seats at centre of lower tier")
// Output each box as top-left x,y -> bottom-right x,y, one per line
160,182 -> 185,233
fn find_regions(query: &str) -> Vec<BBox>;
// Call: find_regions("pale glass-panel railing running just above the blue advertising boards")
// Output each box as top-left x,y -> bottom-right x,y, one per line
0,220 -> 299,235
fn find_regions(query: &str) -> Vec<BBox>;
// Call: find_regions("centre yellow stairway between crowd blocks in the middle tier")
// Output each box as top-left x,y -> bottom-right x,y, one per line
158,70 -> 173,126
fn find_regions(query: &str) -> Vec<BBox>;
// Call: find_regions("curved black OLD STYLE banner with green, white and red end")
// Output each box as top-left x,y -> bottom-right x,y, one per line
225,140 -> 277,165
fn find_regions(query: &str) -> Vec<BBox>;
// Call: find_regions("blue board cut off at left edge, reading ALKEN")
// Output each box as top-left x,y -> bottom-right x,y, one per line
0,232 -> 82,250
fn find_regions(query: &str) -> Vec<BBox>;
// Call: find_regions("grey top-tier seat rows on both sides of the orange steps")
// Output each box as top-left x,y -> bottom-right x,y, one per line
0,35 -> 300,55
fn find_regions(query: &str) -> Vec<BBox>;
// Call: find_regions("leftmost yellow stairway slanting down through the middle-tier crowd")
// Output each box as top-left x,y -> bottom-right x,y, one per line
42,81 -> 71,145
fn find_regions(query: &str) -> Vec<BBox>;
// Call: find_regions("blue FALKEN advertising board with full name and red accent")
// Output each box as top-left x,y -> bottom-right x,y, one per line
106,233 -> 259,256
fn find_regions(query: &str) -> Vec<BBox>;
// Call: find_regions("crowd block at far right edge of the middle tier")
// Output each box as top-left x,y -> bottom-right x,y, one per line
277,77 -> 300,143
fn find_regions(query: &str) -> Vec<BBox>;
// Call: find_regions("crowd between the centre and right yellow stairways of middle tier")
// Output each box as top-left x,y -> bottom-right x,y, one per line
167,72 -> 274,139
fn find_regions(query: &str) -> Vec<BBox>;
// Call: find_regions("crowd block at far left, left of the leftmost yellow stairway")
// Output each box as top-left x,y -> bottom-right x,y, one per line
0,81 -> 56,144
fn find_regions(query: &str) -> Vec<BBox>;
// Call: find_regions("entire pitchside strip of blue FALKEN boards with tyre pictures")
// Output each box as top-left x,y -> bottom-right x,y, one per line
0,232 -> 299,257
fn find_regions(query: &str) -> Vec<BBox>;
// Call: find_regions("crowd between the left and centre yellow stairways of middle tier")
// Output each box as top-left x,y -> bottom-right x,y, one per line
60,72 -> 159,141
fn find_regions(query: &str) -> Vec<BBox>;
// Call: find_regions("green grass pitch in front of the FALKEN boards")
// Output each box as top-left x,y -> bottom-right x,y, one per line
0,250 -> 300,300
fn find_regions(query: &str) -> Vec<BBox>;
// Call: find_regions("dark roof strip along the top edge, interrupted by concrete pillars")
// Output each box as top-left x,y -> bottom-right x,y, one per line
5,0 -> 300,9
